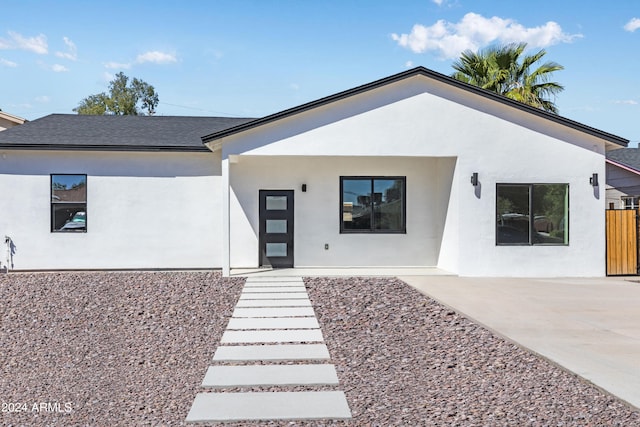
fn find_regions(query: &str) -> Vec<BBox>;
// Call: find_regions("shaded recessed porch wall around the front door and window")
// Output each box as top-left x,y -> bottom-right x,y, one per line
230,156 -> 455,268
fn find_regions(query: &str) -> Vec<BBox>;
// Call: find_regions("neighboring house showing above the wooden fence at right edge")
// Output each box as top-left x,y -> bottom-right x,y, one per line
605,148 -> 640,209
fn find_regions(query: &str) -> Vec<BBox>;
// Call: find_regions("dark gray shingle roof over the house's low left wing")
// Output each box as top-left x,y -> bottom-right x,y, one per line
0,114 -> 253,151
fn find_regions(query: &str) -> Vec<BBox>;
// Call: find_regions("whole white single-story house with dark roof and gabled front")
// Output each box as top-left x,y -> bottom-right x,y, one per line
0,67 -> 628,276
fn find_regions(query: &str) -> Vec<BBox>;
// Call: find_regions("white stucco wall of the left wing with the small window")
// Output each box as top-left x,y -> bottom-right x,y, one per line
0,150 -> 222,269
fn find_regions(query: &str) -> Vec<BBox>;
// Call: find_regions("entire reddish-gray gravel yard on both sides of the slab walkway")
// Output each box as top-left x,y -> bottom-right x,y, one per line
0,272 -> 640,426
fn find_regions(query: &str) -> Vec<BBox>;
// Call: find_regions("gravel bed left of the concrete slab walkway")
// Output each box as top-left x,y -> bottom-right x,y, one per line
0,272 -> 244,426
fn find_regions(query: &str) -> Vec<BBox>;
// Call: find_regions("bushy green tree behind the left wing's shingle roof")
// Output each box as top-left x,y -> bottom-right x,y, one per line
73,72 -> 158,116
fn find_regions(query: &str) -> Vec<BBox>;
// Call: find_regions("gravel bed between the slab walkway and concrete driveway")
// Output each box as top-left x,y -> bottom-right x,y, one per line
305,278 -> 640,426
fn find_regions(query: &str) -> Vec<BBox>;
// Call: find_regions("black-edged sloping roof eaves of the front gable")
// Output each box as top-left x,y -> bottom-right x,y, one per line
202,67 -> 629,147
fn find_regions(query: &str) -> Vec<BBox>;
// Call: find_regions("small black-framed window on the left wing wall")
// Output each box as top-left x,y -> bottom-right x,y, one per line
51,175 -> 87,233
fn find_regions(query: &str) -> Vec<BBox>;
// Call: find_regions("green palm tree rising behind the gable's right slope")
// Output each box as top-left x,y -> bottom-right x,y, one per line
452,43 -> 564,114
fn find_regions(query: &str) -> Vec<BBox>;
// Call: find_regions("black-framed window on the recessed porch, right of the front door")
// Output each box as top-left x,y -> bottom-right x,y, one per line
340,177 -> 406,233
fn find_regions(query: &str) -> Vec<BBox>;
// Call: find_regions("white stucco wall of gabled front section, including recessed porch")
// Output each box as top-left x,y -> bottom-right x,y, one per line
223,77 -> 605,276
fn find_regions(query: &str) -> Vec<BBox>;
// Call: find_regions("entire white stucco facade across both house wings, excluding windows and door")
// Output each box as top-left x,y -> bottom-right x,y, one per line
0,70 -> 624,277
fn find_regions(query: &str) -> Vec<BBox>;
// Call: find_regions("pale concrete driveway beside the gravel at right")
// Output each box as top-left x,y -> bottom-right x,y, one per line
399,276 -> 640,408
